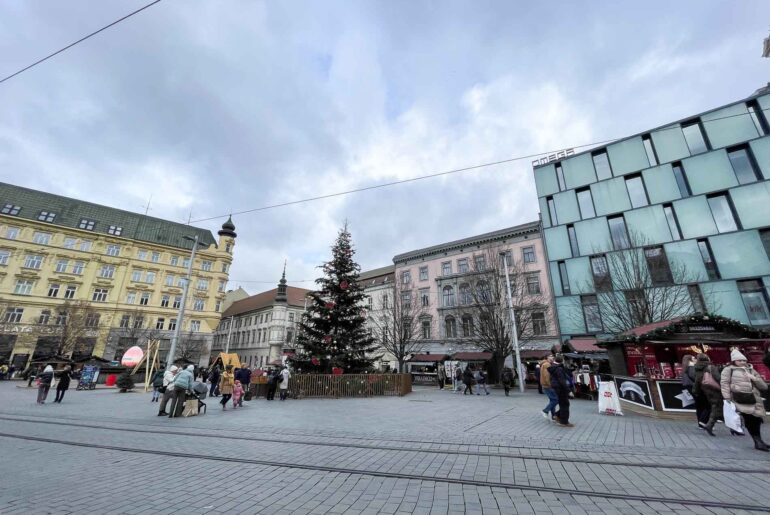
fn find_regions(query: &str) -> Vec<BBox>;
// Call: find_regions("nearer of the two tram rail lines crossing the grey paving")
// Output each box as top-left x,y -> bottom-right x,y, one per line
0,432 -> 770,513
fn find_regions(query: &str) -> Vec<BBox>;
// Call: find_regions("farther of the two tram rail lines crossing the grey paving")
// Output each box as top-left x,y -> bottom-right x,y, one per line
0,416 -> 770,474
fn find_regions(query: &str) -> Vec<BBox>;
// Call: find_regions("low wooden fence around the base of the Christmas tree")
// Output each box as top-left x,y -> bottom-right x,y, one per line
288,374 -> 412,399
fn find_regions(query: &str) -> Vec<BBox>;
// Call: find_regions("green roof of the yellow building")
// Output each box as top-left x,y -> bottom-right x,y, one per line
0,182 -> 216,249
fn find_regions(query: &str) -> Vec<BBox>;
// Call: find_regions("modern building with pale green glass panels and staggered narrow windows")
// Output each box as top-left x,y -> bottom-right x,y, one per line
534,92 -> 770,338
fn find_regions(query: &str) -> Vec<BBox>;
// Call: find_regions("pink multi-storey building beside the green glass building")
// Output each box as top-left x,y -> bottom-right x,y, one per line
393,222 -> 559,360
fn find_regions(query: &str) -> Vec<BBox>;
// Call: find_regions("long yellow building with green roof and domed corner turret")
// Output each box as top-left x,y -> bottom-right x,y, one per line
0,183 -> 236,370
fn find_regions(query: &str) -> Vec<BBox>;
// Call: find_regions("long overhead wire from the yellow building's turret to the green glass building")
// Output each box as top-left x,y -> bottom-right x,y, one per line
188,109 -> 770,224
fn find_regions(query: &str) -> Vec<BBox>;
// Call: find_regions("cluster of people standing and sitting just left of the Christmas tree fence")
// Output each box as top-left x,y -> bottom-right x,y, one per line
151,365 -> 291,417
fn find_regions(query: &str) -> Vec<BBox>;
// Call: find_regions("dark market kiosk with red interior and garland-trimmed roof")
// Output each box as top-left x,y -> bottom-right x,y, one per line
596,315 -> 770,418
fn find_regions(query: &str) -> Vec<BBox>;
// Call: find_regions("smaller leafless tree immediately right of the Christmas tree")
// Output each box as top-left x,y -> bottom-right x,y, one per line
369,278 -> 433,373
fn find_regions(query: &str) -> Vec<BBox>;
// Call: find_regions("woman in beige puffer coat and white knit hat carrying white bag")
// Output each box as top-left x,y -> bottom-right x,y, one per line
721,349 -> 768,452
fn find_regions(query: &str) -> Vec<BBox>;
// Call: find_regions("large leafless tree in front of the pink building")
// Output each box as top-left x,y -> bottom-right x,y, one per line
448,246 -> 550,381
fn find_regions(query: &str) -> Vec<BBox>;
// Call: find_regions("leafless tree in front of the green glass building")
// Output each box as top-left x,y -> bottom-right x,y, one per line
572,232 -> 719,334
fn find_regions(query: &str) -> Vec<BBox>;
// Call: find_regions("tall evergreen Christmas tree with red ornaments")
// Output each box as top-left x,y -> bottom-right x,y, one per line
289,223 -> 380,374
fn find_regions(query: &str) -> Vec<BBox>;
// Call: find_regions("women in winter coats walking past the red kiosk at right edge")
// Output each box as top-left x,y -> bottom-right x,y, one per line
682,349 -> 770,452
